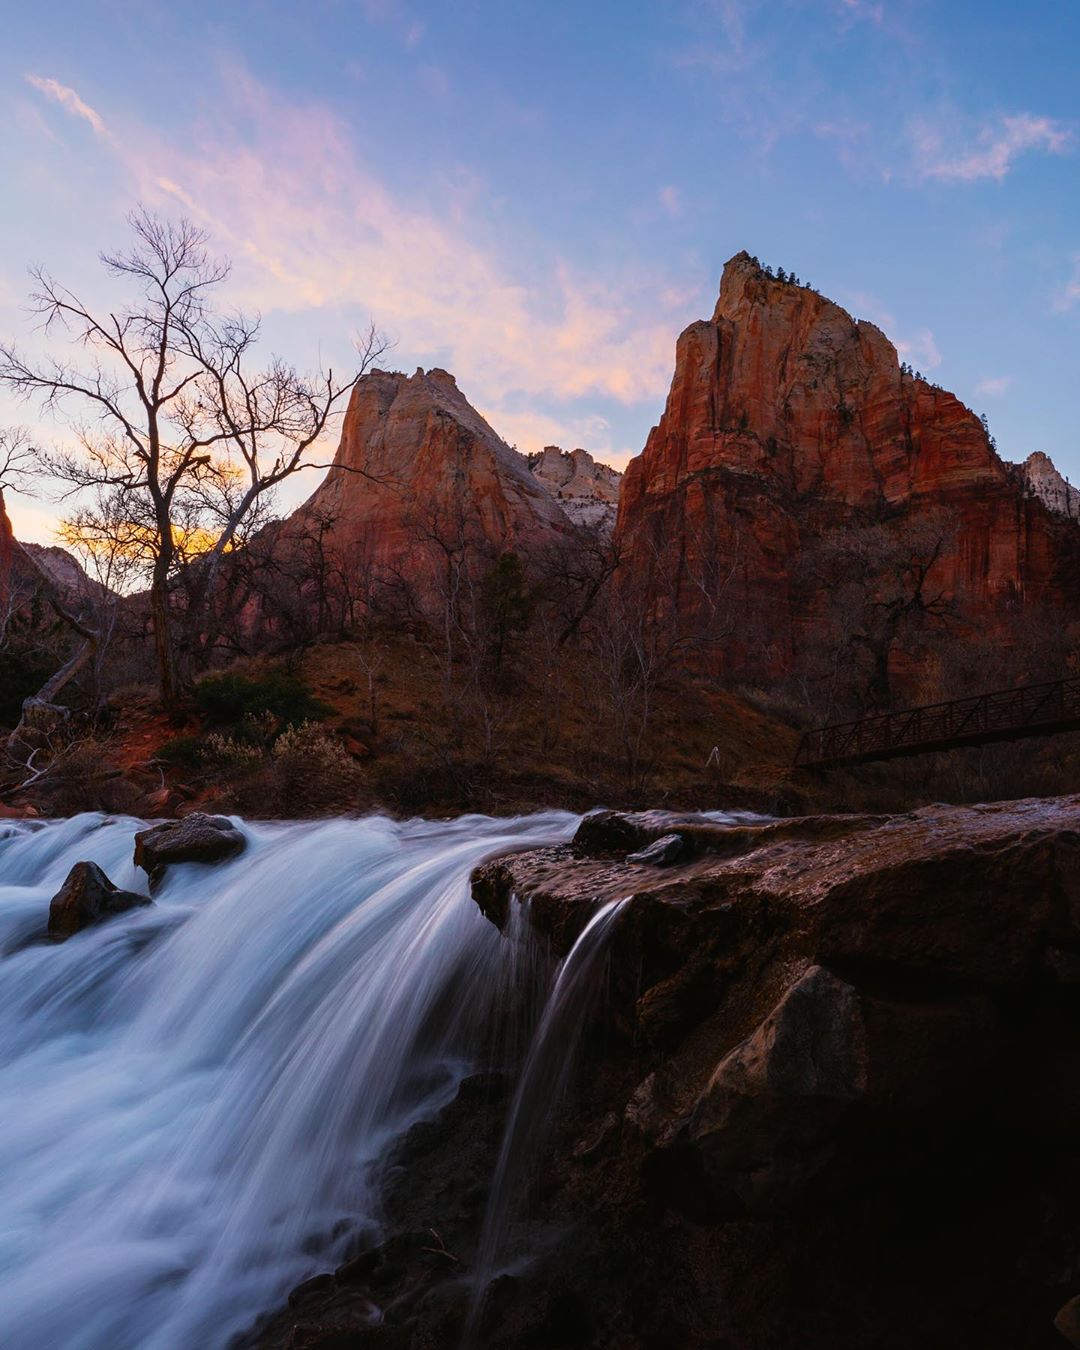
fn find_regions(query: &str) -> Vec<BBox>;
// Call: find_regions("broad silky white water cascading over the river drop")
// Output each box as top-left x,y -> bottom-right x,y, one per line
0,813 -> 576,1350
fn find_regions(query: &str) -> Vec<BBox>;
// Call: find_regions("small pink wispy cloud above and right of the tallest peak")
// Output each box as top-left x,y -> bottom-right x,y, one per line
910,112 -> 1073,182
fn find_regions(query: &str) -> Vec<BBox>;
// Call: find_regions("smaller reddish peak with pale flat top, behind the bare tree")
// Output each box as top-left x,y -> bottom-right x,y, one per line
285,370 -> 575,595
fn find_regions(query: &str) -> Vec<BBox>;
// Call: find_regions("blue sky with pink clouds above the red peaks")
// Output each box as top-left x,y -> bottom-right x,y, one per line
0,0 -> 1080,541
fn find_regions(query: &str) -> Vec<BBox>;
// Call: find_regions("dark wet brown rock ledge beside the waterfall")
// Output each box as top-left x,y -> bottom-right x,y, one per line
254,797 -> 1080,1350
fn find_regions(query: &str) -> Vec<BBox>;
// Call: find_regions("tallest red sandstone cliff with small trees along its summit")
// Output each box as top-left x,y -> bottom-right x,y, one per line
616,254 -> 1080,696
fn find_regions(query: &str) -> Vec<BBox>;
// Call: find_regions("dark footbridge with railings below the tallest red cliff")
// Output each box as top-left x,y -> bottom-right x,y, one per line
795,676 -> 1080,768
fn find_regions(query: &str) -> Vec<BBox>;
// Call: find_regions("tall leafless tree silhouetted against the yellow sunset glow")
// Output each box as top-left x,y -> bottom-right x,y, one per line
0,211 -> 387,705
